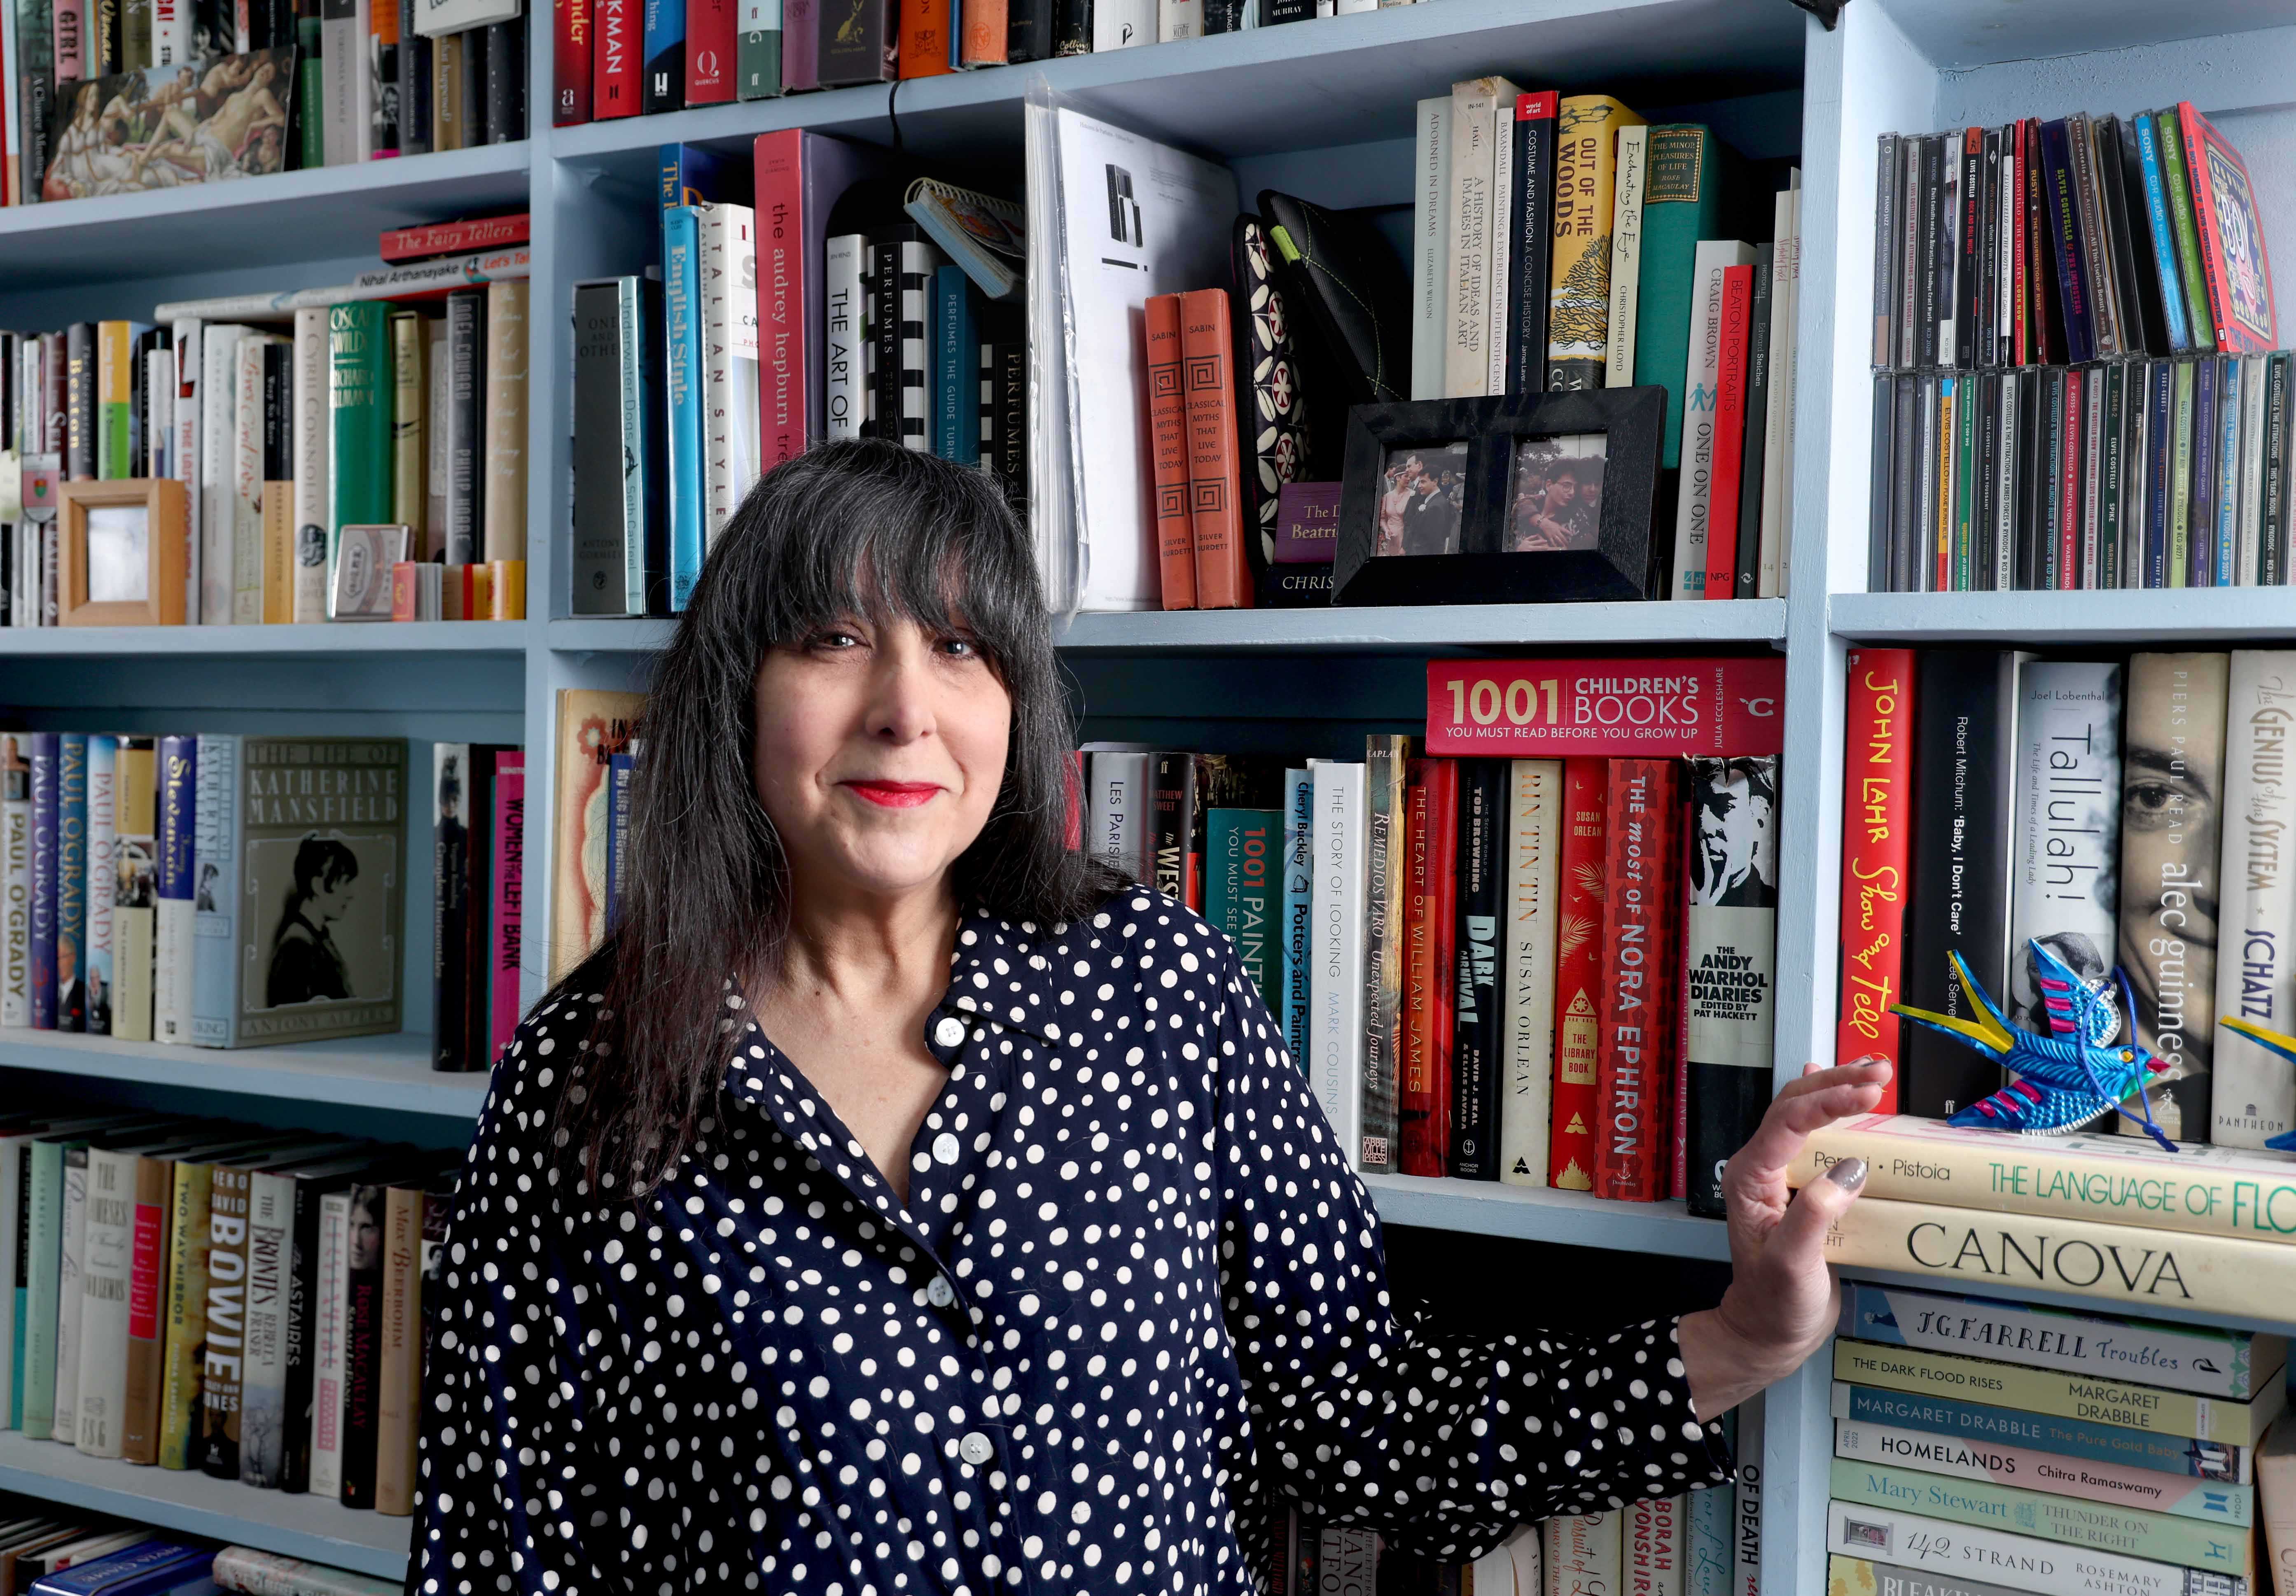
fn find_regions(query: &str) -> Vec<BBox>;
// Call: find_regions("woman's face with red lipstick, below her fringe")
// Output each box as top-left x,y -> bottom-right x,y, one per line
751,620 -> 1013,898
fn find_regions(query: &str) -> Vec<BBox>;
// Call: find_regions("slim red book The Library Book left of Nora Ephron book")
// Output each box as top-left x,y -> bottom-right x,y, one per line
1548,758 -> 1609,1192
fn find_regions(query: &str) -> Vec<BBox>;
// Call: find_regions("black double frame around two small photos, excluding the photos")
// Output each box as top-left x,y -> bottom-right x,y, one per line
1332,386 -> 1667,606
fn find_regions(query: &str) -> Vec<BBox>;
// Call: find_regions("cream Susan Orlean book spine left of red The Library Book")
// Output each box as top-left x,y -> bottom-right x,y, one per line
1499,760 -> 1564,1185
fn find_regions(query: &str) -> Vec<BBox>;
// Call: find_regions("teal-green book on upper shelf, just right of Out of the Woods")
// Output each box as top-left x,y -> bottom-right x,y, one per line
1635,122 -> 1738,471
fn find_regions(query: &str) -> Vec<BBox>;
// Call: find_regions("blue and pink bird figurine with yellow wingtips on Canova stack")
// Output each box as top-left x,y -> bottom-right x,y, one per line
1890,942 -> 2177,1153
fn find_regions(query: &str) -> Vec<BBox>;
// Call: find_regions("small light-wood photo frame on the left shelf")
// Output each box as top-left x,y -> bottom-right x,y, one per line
55,478 -> 188,627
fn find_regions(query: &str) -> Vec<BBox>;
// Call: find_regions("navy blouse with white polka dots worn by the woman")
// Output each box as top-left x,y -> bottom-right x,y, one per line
416,889 -> 1726,1596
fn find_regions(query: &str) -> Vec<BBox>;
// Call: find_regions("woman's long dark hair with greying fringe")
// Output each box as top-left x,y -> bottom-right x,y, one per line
551,441 -> 1121,1192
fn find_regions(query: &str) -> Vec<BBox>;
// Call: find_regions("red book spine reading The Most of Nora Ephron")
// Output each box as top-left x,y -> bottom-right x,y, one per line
1593,760 -> 1683,1203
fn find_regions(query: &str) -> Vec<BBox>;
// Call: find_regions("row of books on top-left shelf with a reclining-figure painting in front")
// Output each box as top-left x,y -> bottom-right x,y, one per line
0,0 -> 528,204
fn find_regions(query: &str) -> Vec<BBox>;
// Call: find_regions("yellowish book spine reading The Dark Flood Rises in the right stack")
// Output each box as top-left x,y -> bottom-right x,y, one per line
1834,1332 -> 2289,1451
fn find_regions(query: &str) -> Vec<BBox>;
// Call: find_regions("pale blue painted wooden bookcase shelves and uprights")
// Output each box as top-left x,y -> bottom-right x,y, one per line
0,0 -> 2296,1596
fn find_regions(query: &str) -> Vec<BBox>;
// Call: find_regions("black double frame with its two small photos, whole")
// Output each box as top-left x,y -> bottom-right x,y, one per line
1332,388 -> 1667,604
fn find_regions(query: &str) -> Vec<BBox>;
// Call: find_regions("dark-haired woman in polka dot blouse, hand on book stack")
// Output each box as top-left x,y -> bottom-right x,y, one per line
416,443 -> 1885,1596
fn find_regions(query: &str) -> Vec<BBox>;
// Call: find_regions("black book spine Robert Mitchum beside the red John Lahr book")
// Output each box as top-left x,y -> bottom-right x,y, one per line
1899,648 -> 2020,1118
